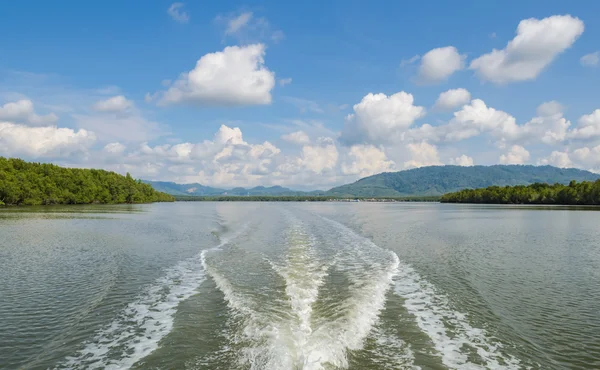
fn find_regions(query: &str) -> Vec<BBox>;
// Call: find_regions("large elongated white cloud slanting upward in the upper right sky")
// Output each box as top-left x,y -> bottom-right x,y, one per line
469,15 -> 584,84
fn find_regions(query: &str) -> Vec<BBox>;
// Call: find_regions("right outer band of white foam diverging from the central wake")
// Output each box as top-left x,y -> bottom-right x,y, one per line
395,264 -> 521,369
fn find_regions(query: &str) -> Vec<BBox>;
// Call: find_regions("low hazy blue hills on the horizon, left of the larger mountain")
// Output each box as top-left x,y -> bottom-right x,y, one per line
144,181 -> 324,196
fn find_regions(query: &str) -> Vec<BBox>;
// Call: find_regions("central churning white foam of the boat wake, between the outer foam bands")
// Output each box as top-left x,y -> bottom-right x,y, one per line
204,214 -> 412,370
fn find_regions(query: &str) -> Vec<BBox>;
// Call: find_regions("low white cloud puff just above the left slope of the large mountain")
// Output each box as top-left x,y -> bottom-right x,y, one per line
341,145 -> 395,177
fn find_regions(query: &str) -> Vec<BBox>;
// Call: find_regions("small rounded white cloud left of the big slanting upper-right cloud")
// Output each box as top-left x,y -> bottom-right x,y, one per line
418,46 -> 465,83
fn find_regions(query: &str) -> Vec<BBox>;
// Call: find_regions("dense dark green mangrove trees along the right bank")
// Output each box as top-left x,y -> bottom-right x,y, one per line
441,180 -> 600,205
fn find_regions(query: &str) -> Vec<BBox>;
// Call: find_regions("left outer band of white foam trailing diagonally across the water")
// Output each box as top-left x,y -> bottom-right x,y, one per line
57,229 -> 243,370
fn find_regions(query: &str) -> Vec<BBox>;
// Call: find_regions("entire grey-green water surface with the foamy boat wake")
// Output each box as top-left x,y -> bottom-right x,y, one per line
0,202 -> 600,370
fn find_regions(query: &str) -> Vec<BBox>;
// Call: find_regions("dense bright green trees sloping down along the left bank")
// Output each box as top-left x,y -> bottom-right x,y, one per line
0,157 -> 175,205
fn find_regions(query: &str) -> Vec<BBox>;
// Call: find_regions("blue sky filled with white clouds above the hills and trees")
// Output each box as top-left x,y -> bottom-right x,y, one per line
0,0 -> 600,190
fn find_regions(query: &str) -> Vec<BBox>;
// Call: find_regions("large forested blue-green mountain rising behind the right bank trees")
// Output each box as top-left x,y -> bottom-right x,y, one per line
326,165 -> 600,197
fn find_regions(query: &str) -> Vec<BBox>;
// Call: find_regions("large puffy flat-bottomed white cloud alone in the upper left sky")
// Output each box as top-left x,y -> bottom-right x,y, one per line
159,44 -> 275,106
